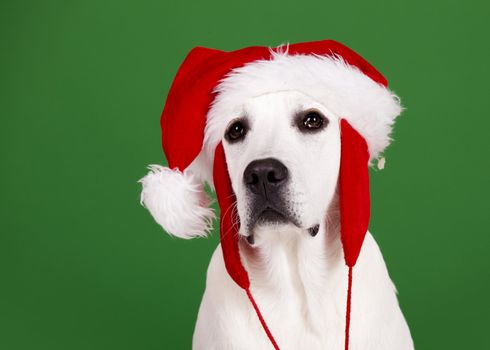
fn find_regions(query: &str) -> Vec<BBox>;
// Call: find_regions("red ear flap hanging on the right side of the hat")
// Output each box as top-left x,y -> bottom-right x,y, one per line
339,119 -> 370,267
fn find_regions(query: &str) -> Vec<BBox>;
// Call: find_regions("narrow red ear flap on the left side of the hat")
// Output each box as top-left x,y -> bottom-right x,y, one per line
213,142 -> 250,289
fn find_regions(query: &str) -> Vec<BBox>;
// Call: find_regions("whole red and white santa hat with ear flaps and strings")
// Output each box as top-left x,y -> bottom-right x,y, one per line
141,40 -> 401,349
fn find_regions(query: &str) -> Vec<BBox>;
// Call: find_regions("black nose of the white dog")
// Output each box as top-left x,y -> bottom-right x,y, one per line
243,158 -> 289,198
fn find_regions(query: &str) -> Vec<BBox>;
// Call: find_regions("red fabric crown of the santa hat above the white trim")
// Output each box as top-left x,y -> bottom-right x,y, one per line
160,40 -> 387,170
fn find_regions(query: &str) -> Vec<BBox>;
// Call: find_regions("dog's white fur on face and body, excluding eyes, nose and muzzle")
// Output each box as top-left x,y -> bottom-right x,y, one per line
193,91 -> 413,350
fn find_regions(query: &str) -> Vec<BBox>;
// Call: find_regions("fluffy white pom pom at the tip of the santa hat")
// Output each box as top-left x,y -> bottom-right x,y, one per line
139,164 -> 214,239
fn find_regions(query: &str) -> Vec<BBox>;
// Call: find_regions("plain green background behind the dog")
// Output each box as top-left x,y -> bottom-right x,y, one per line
0,0 -> 490,350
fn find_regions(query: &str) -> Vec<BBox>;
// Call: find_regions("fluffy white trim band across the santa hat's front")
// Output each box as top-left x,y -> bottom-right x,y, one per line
205,44 -> 402,163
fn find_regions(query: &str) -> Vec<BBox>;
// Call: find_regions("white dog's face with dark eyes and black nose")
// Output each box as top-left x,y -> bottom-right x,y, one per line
222,91 -> 340,243
